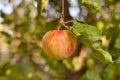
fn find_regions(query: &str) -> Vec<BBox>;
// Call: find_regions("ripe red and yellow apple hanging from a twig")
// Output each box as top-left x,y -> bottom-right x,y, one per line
42,30 -> 77,60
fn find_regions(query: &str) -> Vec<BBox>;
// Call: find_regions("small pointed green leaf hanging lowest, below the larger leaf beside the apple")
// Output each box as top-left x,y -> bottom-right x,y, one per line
93,49 -> 113,63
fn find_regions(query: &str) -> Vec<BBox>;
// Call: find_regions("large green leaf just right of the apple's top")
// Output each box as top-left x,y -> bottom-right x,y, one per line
70,23 -> 102,48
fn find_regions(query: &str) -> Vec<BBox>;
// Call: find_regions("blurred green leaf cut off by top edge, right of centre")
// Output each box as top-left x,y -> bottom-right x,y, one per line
81,0 -> 102,11
